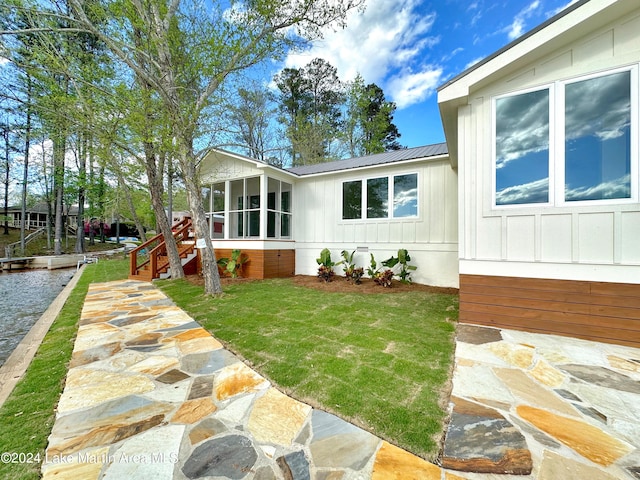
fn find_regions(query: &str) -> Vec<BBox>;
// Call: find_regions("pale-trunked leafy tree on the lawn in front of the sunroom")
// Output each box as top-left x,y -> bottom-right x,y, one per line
70,0 -> 362,294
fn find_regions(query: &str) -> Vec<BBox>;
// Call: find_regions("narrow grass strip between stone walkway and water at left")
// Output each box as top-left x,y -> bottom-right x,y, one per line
0,259 -> 129,480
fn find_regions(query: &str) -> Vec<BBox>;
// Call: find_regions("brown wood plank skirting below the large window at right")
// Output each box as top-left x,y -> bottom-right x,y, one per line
460,275 -> 640,347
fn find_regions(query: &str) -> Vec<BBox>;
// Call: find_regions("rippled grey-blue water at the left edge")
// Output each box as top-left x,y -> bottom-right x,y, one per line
0,269 -> 75,365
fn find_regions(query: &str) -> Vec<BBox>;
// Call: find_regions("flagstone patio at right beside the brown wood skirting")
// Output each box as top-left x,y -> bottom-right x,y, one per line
442,325 -> 640,480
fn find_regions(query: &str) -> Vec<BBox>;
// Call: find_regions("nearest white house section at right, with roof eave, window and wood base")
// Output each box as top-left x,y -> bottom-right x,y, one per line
438,0 -> 640,346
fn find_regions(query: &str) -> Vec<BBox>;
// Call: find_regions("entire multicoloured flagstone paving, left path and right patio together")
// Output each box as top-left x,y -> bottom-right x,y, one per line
42,281 -> 640,480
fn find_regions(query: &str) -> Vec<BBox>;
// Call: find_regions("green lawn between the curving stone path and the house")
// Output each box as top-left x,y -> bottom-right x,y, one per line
158,279 -> 458,460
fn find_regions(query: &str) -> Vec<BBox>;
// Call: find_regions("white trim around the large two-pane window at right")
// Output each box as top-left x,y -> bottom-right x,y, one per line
491,64 -> 640,210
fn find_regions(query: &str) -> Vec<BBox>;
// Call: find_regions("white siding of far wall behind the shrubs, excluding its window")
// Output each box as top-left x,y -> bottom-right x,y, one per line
293,158 -> 458,288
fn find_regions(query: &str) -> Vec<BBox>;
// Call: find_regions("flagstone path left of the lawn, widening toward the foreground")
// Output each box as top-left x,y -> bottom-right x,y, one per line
42,281 -> 460,480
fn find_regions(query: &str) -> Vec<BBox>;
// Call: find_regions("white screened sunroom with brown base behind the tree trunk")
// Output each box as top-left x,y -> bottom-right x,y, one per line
201,150 -> 295,278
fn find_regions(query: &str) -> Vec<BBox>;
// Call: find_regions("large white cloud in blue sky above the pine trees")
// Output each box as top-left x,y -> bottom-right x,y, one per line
285,0 -> 442,108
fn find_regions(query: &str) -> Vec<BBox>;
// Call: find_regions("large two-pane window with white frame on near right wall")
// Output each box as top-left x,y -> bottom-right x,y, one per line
493,67 -> 638,207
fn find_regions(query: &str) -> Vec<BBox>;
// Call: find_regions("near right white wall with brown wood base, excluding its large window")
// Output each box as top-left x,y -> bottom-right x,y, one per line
458,4 -> 640,346
